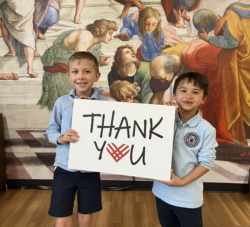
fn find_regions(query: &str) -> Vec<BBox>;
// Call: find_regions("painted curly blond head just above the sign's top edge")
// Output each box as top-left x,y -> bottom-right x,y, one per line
109,80 -> 138,102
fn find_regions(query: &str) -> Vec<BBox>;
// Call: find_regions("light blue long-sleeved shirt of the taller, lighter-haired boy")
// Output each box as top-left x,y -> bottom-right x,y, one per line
46,89 -> 110,172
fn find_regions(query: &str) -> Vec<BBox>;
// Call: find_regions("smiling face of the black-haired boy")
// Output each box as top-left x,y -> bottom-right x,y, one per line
174,79 -> 206,115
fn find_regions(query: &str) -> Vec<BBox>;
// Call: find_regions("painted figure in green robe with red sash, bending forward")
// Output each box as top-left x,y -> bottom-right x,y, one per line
38,19 -> 118,110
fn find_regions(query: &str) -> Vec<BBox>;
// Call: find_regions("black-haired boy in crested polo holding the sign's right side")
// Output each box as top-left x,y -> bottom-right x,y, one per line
152,72 -> 218,227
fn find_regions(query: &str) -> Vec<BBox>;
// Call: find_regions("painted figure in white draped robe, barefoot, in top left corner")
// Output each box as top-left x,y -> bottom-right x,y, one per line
1,0 -> 37,78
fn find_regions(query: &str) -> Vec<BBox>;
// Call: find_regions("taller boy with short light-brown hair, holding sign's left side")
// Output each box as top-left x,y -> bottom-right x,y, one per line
47,52 -> 108,227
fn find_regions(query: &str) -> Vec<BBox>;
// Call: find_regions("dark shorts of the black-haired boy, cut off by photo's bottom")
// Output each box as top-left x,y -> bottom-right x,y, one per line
156,197 -> 203,227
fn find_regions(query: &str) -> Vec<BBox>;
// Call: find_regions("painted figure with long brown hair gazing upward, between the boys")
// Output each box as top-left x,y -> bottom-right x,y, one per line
108,45 -> 152,103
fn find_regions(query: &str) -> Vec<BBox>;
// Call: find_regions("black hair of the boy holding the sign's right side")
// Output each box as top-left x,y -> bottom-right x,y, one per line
173,72 -> 209,97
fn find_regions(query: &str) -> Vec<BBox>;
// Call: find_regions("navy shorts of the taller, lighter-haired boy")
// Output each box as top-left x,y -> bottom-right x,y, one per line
49,167 -> 102,218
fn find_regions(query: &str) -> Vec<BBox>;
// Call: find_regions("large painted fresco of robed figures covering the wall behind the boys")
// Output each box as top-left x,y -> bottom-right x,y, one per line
0,0 -> 250,183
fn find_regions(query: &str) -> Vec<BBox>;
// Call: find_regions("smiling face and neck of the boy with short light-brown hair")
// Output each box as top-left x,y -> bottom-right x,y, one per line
68,59 -> 100,97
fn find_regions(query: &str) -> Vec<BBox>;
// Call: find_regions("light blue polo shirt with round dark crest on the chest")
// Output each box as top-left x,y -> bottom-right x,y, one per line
152,111 -> 218,208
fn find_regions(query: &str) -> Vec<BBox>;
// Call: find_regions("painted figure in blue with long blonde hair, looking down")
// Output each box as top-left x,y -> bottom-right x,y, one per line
115,7 -> 182,61
